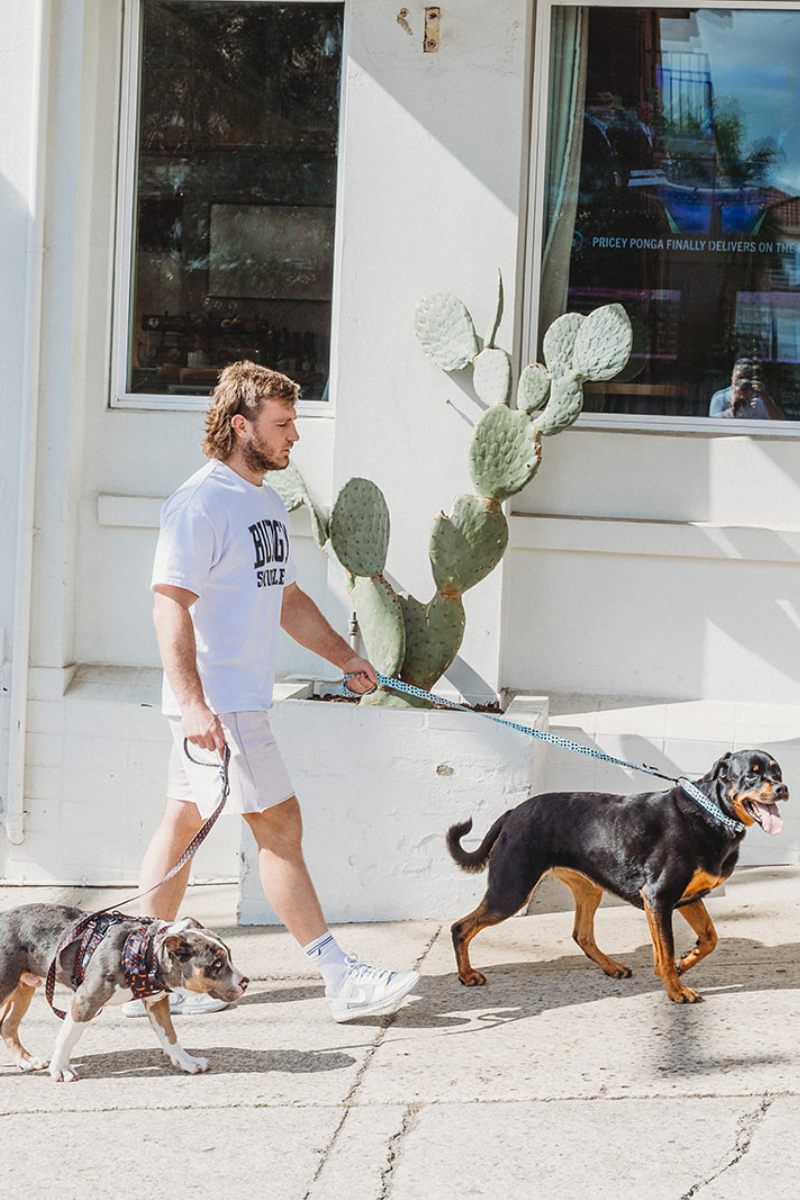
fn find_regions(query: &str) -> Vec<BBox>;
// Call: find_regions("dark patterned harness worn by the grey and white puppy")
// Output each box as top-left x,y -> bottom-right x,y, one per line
44,912 -> 170,1020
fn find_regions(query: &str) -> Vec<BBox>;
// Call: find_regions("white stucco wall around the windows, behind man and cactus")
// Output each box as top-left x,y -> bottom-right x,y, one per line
0,0 -> 800,881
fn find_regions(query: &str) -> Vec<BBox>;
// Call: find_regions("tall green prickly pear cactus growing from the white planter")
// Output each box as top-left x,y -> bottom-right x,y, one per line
283,272 -> 632,707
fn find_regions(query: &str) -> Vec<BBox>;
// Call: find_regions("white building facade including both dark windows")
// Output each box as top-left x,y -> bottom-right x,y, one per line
0,0 -> 800,882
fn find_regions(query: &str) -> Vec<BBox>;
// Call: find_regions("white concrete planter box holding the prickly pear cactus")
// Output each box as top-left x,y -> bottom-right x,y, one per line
239,697 -> 547,925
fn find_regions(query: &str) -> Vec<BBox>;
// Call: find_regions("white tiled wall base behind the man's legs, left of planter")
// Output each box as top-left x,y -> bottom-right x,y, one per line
2,667 -> 240,892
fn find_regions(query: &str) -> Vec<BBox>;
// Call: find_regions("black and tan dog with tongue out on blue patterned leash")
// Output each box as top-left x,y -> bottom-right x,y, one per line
447,750 -> 789,1003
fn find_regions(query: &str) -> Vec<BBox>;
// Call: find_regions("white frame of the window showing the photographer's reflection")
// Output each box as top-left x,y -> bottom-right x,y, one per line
522,0 -> 800,439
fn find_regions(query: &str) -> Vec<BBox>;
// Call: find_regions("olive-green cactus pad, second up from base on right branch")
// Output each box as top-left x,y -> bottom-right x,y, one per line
429,496 -> 509,595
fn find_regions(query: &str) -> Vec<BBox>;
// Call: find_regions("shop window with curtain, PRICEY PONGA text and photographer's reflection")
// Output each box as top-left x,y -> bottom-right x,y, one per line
536,5 -> 800,432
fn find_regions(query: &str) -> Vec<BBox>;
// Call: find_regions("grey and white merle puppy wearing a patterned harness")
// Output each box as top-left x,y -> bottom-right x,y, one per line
0,904 -> 248,1082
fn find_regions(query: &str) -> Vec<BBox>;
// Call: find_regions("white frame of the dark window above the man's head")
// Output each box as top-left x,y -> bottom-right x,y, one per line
109,0 -> 350,418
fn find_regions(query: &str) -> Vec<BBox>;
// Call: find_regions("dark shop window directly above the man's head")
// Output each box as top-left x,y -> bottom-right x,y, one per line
115,0 -> 343,408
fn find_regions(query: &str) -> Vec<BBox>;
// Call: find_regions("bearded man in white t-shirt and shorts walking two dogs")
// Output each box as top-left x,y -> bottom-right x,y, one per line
126,361 -> 419,1021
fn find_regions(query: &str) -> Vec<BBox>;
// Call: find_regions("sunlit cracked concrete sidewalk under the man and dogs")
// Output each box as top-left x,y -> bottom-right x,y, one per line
0,868 -> 800,1200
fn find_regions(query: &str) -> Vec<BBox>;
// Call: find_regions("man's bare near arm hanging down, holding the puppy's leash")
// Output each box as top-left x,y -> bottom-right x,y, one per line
152,583 -> 225,754
